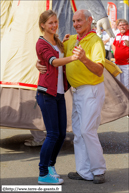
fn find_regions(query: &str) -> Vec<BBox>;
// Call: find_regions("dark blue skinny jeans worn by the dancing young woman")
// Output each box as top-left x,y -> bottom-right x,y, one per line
36,91 -> 67,176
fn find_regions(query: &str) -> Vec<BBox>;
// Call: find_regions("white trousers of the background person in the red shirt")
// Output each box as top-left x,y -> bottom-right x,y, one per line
117,65 -> 129,89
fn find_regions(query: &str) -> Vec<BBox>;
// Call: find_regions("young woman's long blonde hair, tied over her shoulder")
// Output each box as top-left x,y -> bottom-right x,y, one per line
39,10 -> 64,53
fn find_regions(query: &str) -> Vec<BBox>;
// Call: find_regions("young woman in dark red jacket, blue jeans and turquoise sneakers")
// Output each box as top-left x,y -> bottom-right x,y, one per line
36,10 -> 78,184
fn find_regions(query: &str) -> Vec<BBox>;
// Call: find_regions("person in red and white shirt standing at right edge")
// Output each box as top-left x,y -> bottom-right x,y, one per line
112,19 -> 129,89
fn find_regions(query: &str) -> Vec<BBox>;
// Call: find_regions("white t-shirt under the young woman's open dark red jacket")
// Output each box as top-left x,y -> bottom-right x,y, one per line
54,45 -> 64,94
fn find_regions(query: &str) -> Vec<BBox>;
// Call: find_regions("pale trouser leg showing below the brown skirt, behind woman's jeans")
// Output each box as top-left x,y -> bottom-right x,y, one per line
30,130 -> 46,142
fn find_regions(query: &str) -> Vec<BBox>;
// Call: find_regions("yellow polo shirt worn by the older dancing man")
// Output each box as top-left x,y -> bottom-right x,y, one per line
64,33 -> 105,88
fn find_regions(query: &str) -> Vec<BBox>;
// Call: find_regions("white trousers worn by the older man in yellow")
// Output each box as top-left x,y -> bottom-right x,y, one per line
72,82 -> 106,180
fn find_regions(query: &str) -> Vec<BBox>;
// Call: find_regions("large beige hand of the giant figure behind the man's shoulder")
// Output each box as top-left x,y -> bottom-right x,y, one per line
97,17 -> 115,38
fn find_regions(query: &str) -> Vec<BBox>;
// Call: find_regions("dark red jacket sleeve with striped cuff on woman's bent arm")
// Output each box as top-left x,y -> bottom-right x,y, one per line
36,43 -> 56,65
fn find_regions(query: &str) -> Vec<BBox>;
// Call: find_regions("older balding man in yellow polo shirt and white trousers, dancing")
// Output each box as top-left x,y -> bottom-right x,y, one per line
64,10 -> 106,184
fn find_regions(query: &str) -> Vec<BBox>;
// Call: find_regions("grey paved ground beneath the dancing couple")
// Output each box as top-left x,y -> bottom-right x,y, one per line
0,117 -> 129,193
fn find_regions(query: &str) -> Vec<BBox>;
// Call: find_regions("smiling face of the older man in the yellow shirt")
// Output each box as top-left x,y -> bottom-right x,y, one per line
73,11 -> 91,35
